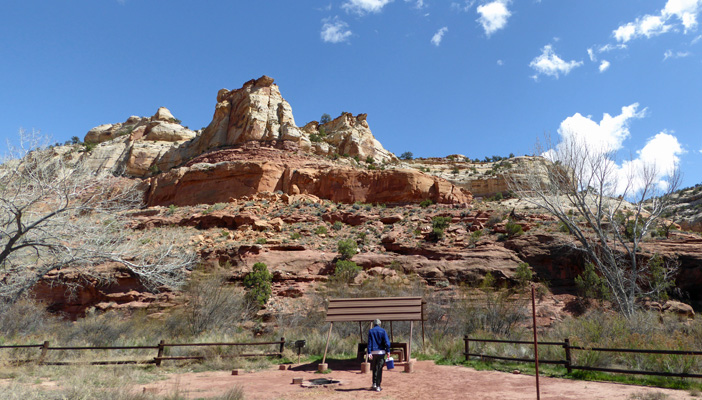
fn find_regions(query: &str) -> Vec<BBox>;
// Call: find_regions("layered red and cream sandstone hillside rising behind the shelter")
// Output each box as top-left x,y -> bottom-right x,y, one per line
11,76 -> 702,319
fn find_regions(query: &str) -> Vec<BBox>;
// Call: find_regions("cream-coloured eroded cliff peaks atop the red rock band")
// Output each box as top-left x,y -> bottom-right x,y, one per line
81,76 -> 397,177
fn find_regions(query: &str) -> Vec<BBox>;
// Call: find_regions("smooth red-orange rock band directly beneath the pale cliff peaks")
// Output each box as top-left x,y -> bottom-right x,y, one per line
147,143 -> 472,206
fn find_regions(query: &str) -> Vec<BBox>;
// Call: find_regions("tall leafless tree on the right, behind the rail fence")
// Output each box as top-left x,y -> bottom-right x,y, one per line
506,138 -> 680,317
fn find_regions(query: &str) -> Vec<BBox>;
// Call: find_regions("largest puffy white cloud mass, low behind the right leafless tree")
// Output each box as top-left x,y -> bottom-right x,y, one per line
544,103 -> 684,194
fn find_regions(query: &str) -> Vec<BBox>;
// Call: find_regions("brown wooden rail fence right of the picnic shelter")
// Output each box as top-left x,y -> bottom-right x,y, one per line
463,336 -> 702,378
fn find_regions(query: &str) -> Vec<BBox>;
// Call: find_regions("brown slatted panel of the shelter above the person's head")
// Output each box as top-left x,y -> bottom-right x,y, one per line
325,297 -> 426,322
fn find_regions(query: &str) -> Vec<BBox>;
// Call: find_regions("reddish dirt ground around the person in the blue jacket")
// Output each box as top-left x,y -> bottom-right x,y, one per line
144,361 -> 693,400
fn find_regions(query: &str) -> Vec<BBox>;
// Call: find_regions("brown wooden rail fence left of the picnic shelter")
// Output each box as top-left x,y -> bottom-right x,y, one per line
0,338 -> 285,366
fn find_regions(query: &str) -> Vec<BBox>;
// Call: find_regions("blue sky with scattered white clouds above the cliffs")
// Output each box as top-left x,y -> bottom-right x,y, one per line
0,0 -> 702,186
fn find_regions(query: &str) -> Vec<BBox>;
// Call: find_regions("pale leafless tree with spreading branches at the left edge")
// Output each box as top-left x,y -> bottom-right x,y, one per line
0,131 -> 195,303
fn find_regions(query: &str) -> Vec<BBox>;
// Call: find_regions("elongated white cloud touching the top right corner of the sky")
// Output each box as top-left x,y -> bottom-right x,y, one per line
612,0 -> 702,43
